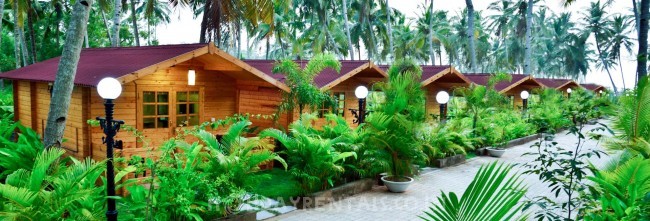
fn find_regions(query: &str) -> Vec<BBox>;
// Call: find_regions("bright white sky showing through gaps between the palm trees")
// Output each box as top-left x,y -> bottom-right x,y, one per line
156,0 -> 637,88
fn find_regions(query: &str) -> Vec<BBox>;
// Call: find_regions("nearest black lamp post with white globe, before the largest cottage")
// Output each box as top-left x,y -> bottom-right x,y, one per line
97,77 -> 124,221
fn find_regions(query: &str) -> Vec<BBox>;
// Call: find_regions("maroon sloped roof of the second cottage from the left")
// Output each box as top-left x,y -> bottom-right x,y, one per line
244,60 -> 369,88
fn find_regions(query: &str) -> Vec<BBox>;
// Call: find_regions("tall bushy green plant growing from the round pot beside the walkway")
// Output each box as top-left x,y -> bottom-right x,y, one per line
364,60 -> 426,180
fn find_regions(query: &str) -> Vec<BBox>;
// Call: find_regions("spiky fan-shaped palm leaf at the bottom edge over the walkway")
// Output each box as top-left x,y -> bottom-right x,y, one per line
420,162 -> 528,221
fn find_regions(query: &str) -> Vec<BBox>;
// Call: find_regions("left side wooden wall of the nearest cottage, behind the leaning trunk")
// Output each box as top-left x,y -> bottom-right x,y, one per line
14,81 -> 91,158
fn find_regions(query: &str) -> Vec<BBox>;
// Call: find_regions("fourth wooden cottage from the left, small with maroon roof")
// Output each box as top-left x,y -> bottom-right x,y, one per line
465,74 -> 544,108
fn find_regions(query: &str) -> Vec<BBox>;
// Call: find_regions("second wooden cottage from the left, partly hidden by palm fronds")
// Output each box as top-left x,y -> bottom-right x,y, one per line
246,60 -> 388,126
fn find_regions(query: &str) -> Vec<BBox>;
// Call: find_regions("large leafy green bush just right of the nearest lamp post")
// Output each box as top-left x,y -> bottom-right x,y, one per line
123,120 -> 284,220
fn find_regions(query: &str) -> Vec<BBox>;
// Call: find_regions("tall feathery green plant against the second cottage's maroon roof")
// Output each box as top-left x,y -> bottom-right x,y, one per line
273,53 -> 341,114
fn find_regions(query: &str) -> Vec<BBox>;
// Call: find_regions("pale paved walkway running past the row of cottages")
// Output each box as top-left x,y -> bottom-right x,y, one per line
269,121 -> 609,221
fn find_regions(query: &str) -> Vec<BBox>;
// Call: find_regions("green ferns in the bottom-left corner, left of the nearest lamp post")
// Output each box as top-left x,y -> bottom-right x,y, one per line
0,148 -> 133,220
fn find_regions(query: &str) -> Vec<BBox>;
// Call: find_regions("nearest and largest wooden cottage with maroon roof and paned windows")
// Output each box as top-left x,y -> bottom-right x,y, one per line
0,43 -> 289,159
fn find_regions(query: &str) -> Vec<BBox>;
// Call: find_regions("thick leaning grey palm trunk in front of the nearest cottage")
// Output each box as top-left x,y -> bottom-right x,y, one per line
43,0 -> 93,148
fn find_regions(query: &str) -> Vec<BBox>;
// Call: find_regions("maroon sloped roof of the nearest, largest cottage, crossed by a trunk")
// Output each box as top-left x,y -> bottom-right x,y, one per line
0,44 -> 207,87
